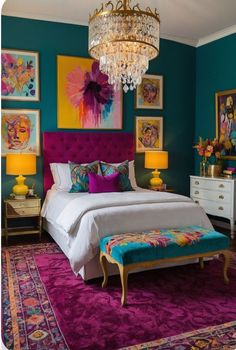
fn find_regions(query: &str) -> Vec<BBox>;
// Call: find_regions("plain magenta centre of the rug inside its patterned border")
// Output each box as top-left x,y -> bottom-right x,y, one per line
35,254 -> 236,350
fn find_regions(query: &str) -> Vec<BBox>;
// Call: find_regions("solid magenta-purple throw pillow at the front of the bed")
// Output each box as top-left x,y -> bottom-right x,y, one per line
88,173 -> 120,193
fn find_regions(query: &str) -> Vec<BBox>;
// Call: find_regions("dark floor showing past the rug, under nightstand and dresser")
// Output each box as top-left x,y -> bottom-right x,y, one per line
2,226 -> 236,252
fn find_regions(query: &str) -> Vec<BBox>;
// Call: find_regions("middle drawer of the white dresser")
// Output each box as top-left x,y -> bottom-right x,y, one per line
190,187 -> 233,204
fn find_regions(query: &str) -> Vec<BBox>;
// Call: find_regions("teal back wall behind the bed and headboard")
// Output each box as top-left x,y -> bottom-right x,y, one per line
2,16 -> 196,198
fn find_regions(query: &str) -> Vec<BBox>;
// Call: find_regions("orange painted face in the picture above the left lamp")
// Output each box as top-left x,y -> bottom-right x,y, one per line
3,115 -> 31,150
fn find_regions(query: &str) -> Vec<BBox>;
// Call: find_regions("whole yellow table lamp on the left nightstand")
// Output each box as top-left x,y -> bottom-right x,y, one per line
6,153 -> 36,199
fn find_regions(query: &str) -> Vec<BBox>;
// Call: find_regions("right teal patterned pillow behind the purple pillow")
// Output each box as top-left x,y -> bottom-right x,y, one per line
100,160 -> 134,191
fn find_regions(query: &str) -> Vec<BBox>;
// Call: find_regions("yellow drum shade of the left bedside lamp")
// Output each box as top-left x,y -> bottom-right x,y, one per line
6,153 -> 36,175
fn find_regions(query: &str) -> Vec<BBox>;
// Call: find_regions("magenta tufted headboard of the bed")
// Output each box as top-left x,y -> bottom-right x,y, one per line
43,131 -> 134,193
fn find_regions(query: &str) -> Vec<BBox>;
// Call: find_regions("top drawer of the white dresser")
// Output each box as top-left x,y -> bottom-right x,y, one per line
191,178 -> 232,192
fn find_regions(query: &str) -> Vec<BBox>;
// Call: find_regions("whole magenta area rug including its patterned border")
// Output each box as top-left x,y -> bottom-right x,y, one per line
2,243 -> 236,350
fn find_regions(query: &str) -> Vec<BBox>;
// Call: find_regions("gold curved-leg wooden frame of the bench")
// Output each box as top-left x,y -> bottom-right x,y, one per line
100,250 -> 231,305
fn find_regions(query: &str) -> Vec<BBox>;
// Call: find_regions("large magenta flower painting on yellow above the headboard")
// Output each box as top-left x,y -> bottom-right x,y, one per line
57,56 -> 123,129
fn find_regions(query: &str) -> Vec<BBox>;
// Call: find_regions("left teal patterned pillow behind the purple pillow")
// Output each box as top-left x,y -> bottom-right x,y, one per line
69,160 -> 99,193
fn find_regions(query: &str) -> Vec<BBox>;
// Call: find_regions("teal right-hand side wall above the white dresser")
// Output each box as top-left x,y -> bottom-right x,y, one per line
194,34 -> 236,174
